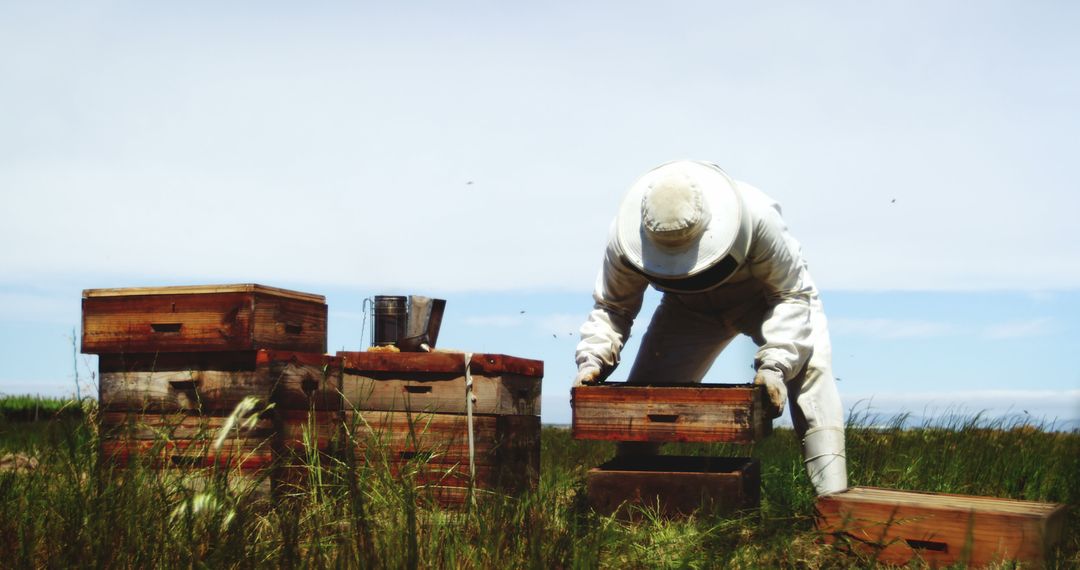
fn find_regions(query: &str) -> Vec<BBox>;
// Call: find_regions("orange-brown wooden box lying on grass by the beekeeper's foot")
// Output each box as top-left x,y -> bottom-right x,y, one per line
818,487 -> 1065,566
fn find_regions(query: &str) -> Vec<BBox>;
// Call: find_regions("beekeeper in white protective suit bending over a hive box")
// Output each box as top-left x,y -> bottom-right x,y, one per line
575,161 -> 848,494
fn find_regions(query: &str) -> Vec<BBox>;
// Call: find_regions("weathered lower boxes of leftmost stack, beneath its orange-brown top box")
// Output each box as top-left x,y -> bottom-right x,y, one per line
98,350 -> 342,490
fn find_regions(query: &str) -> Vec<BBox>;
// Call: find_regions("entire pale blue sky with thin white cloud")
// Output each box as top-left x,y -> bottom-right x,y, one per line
0,1 -> 1080,421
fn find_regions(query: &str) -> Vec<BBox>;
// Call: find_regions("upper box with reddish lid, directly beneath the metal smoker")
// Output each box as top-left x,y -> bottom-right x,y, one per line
337,352 -> 543,416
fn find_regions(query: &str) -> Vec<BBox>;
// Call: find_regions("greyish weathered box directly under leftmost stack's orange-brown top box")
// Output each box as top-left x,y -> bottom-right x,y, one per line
98,350 -> 341,412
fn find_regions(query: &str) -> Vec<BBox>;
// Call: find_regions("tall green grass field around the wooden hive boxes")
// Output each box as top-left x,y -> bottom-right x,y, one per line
0,402 -> 1080,568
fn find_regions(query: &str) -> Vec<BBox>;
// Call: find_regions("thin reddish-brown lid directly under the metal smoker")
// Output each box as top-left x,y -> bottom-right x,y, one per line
337,352 -> 543,378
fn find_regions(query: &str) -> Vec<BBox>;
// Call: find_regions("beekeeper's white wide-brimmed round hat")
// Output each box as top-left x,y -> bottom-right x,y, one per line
616,161 -> 751,291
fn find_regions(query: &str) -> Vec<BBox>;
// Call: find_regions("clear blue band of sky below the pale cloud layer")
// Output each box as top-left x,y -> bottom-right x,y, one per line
0,283 -> 1080,426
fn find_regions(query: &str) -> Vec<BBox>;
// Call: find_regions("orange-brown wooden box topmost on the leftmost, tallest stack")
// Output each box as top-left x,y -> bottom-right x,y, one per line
82,284 -> 326,354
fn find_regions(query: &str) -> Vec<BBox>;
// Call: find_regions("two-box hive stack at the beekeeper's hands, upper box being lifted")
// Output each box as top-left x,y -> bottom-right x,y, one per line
571,383 -> 772,516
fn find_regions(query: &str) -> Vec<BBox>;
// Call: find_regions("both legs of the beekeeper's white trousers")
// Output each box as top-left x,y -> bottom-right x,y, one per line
618,295 -> 848,494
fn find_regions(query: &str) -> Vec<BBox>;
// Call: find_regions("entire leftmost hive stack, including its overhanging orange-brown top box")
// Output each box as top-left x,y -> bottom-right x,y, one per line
82,285 -> 330,487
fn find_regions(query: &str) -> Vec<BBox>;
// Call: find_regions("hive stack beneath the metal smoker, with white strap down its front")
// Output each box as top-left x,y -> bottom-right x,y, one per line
338,352 -> 543,505
